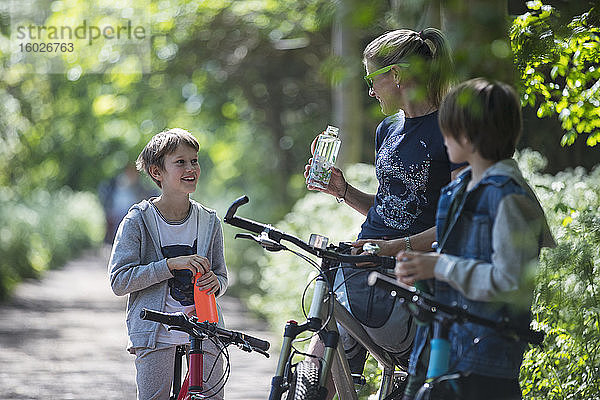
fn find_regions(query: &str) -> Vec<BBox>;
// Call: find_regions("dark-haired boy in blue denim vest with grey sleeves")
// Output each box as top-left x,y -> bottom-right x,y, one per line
396,78 -> 554,400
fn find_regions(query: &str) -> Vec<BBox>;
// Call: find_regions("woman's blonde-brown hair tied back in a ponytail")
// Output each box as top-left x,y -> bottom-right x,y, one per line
363,28 -> 454,107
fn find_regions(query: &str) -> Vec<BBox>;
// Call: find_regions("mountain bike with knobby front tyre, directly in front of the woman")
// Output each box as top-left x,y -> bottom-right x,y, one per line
223,196 -> 407,400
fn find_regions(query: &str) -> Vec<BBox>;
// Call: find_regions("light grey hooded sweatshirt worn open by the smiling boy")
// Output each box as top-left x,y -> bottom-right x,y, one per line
108,200 -> 227,351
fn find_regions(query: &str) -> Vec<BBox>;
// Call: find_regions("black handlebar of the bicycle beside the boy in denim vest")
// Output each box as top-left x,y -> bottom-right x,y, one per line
368,272 -> 545,346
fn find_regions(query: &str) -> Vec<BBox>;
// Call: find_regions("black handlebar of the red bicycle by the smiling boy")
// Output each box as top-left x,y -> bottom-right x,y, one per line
140,308 -> 271,356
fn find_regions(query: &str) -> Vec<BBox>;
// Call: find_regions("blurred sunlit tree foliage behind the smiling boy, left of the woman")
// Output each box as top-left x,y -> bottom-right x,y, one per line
0,0 -> 334,296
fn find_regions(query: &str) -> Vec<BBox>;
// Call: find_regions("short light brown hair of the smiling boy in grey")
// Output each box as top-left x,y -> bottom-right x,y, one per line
135,128 -> 200,187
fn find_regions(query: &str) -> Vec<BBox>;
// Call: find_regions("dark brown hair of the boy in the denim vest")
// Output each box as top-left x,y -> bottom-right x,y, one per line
438,78 -> 523,161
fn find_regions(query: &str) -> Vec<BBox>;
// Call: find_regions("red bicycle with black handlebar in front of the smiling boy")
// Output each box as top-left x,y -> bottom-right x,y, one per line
140,309 -> 270,400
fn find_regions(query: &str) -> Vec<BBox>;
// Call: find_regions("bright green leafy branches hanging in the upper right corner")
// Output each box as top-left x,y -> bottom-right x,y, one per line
510,0 -> 600,146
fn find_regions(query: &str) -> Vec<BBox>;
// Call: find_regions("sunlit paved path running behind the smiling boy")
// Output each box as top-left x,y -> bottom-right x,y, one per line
0,249 -> 277,400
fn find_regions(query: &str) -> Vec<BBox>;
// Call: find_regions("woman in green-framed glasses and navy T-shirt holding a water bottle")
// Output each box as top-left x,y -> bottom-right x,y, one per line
305,28 -> 460,390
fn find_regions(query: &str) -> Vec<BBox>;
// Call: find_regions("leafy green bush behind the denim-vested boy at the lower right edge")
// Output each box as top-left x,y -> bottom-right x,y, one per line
521,152 -> 600,399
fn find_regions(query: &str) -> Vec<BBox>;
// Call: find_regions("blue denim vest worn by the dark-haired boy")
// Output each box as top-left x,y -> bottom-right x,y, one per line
409,171 -> 530,379
